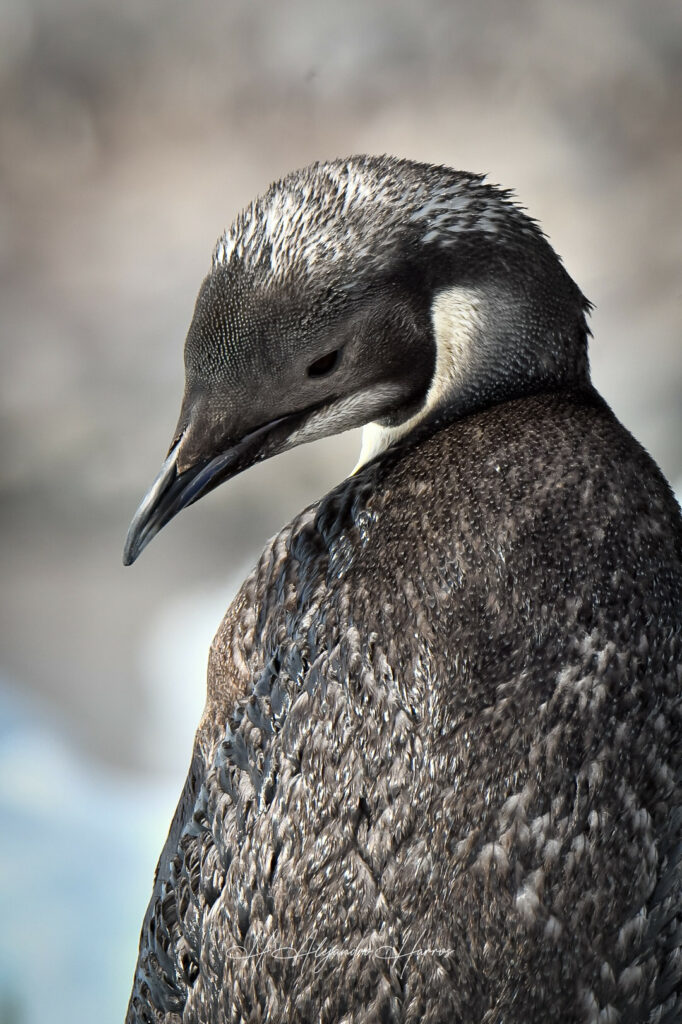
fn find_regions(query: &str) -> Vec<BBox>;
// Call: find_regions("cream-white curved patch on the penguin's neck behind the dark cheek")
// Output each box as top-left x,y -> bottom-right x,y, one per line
353,287 -> 483,473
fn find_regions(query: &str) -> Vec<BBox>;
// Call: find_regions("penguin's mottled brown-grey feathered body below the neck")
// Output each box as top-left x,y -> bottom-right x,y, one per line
127,155 -> 682,1024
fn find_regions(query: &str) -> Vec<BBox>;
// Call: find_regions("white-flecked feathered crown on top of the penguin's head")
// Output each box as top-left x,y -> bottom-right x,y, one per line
213,156 -> 542,282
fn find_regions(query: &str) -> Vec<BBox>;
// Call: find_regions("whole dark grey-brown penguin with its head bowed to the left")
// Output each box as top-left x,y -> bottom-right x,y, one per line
124,156 -> 682,1024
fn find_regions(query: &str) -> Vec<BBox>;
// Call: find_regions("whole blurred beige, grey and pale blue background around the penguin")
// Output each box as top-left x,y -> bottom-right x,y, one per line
0,0 -> 682,1024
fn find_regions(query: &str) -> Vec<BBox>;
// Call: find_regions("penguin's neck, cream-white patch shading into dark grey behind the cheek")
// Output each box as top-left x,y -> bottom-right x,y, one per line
353,286 -> 590,473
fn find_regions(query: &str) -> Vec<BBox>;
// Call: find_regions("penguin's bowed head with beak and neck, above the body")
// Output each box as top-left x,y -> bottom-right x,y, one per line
124,157 -> 589,564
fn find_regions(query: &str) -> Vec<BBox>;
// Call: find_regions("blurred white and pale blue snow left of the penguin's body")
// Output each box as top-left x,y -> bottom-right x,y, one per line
0,587 -> 240,1024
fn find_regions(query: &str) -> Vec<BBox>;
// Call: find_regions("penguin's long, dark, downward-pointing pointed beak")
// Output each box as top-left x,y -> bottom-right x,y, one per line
123,414 -> 294,565
